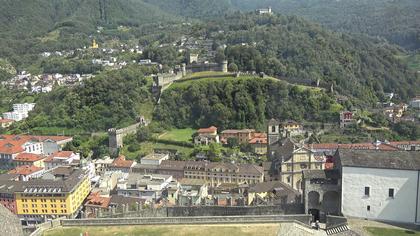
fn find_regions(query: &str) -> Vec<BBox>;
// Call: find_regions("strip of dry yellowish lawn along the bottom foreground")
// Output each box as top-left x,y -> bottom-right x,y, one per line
44,224 -> 279,236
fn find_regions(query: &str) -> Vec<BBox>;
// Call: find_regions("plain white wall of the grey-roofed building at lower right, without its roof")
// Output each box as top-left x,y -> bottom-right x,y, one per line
341,167 -> 420,223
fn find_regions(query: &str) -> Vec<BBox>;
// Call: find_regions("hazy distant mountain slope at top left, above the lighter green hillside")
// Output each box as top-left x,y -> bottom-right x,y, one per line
0,0 -> 176,38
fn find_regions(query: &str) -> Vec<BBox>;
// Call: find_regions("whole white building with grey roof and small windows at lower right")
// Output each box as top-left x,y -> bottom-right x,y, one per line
336,149 -> 420,223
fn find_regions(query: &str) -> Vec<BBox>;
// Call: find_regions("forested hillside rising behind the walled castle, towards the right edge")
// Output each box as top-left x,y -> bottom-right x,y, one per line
203,14 -> 420,104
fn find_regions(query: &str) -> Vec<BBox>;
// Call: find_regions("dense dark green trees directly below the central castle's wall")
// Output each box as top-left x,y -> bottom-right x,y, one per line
154,77 -> 341,129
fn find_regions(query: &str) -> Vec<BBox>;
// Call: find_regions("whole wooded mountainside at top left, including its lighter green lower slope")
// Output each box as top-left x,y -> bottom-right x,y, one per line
0,0 -> 177,64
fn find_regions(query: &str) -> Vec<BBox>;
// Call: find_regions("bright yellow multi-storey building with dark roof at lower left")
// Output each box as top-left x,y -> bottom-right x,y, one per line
16,169 -> 91,222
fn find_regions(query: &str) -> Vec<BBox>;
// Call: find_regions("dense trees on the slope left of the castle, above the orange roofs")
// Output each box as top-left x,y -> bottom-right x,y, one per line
18,67 -> 152,132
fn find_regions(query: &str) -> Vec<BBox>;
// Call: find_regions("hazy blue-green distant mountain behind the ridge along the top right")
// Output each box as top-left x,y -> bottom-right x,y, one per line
144,0 -> 420,49
